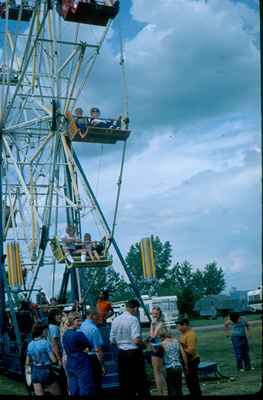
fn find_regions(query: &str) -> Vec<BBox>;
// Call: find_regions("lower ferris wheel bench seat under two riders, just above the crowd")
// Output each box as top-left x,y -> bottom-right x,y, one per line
50,237 -> 112,269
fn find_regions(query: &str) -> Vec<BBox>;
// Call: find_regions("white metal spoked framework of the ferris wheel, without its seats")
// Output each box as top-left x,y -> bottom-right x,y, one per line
0,0 -> 146,310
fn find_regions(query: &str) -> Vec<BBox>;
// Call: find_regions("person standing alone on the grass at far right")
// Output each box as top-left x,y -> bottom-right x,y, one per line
224,312 -> 254,372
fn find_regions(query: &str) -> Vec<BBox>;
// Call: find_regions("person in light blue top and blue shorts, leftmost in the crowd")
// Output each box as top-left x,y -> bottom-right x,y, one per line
26,324 -> 61,396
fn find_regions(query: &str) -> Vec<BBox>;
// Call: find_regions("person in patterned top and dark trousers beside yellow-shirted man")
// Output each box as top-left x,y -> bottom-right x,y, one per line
159,327 -> 188,399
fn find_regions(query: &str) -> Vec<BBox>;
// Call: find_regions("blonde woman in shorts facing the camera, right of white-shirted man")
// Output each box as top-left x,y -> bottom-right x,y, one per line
150,306 -> 167,396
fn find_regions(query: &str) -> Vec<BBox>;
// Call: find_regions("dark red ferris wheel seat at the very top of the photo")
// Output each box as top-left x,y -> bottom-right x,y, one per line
57,0 -> 119,26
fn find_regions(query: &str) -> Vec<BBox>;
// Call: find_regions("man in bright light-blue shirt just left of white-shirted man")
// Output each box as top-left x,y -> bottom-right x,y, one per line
80,308 -> 105,395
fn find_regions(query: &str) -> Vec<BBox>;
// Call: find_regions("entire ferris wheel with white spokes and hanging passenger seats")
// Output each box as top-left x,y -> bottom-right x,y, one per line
0,0 -> 147,325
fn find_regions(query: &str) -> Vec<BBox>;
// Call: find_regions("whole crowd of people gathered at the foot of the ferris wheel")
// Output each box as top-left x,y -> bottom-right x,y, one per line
22,291 -> 205,399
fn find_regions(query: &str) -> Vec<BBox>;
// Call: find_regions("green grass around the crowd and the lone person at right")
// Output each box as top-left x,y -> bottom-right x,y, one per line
0,321 -> 262,396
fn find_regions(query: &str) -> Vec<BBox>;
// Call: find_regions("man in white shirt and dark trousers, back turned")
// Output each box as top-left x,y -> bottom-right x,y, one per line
110,299 -> 150,399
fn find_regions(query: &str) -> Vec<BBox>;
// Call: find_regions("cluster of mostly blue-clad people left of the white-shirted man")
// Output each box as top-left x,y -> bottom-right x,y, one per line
26,290 -> 113,396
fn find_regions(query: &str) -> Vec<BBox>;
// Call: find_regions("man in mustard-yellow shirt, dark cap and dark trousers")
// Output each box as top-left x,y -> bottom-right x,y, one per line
177,318 -> 201,399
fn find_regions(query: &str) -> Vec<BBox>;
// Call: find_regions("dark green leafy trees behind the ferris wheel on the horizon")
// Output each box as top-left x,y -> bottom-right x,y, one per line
81,235 -> 225,315
